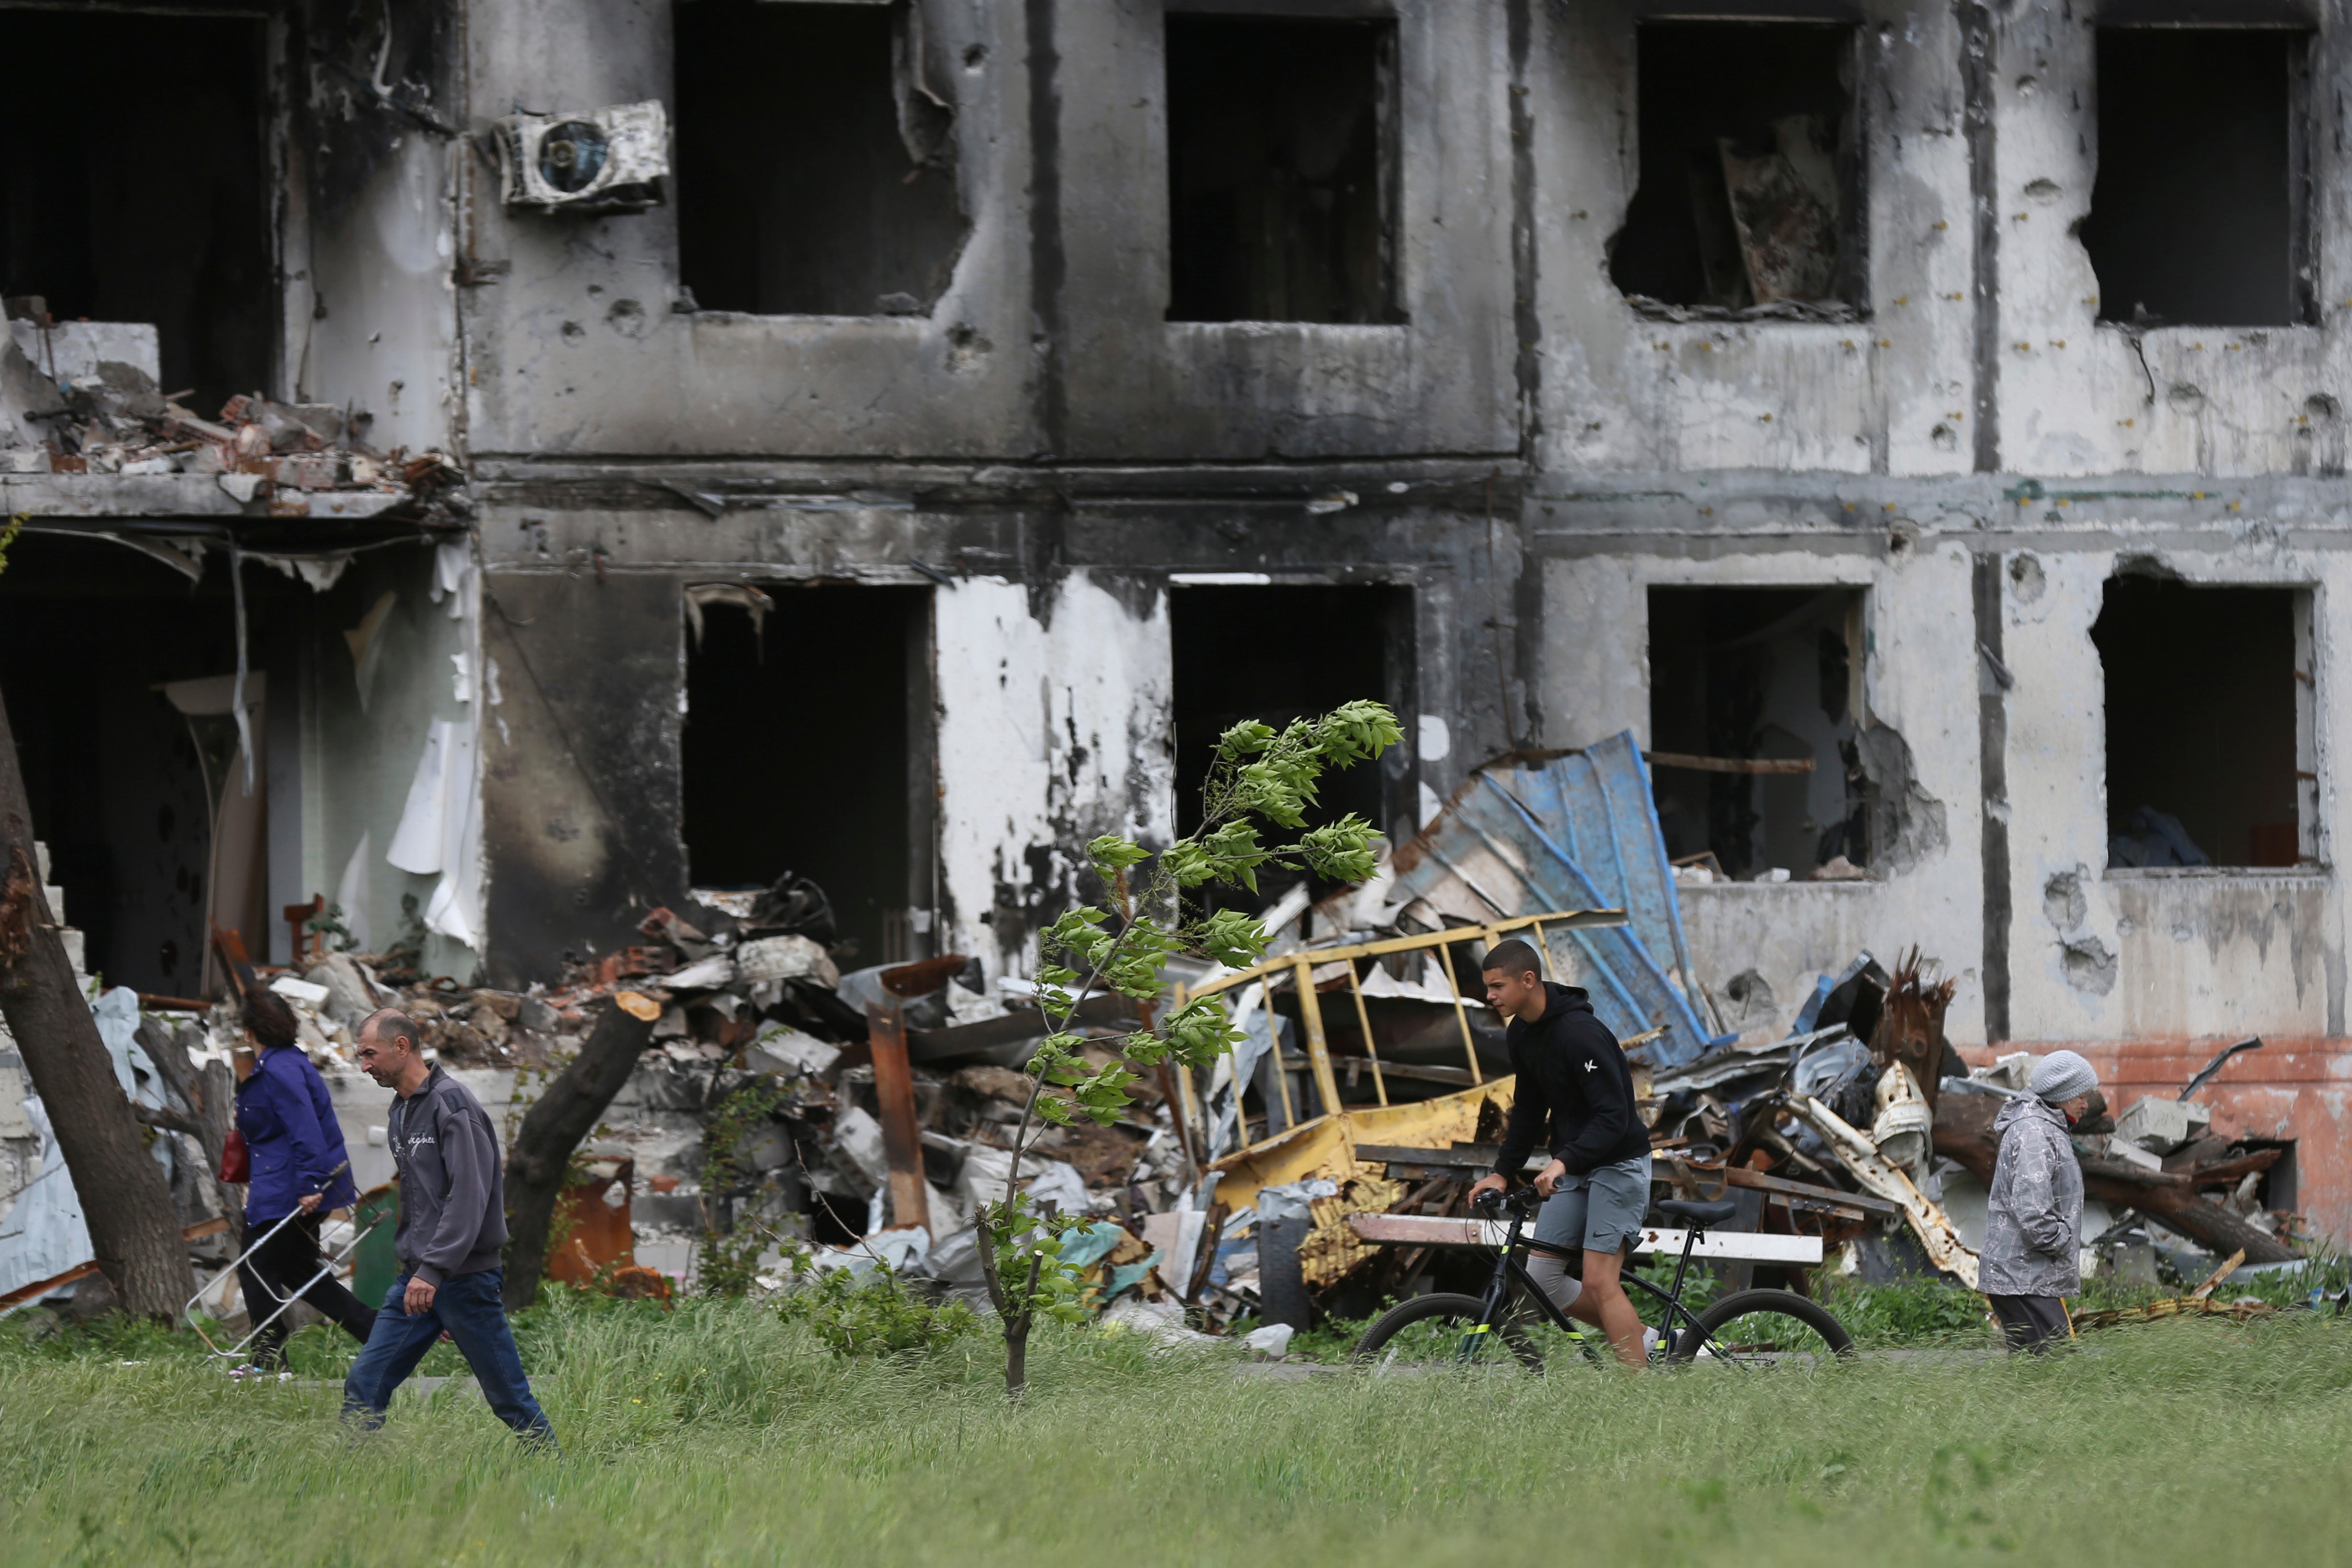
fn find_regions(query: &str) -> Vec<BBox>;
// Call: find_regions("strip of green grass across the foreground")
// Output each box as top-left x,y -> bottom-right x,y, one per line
0,1302 -> 2352,1568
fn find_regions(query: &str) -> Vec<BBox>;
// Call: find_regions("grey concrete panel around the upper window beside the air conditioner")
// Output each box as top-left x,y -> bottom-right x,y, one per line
461,0 -> 1042,456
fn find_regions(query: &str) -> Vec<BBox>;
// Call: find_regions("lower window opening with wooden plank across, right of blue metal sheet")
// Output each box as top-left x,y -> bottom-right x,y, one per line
1649,588 -> 1870,881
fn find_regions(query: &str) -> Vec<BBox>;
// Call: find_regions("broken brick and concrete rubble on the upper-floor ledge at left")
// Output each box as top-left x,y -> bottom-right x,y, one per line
0,296 -> 463,517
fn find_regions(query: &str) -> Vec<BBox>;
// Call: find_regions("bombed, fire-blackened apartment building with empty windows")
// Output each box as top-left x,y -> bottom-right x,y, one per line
0,0 -> 2352,1232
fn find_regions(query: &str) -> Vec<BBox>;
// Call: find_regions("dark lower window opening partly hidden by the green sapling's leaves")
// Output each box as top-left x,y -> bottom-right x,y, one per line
1169,586 -> 1414,914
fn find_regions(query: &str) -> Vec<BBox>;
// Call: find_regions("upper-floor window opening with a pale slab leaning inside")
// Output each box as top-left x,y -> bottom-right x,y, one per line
1609,21 -> 1863,310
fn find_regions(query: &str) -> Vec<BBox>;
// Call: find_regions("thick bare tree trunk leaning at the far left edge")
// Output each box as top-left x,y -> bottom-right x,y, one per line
0,700 -> 195,1323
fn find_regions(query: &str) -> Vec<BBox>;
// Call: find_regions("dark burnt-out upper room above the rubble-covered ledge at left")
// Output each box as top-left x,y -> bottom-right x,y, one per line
0,7 -> 278,411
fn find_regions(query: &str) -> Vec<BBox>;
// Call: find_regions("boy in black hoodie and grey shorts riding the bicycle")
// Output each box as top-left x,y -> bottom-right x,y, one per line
1470,938 -> 1651,1368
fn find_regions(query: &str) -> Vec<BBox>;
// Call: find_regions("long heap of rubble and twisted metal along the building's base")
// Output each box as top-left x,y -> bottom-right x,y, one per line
18,747 -> 2317,1354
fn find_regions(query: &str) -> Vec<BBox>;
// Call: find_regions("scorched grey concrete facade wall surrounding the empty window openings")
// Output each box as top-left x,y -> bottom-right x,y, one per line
96,0 -> 2352,1220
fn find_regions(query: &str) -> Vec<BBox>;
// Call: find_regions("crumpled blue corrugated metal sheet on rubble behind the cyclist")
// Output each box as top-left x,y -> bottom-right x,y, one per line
1392,738 -> 1724,1067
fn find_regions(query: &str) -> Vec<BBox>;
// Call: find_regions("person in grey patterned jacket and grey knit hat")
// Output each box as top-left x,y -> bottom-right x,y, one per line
1976,1051 -> 2098,1354
